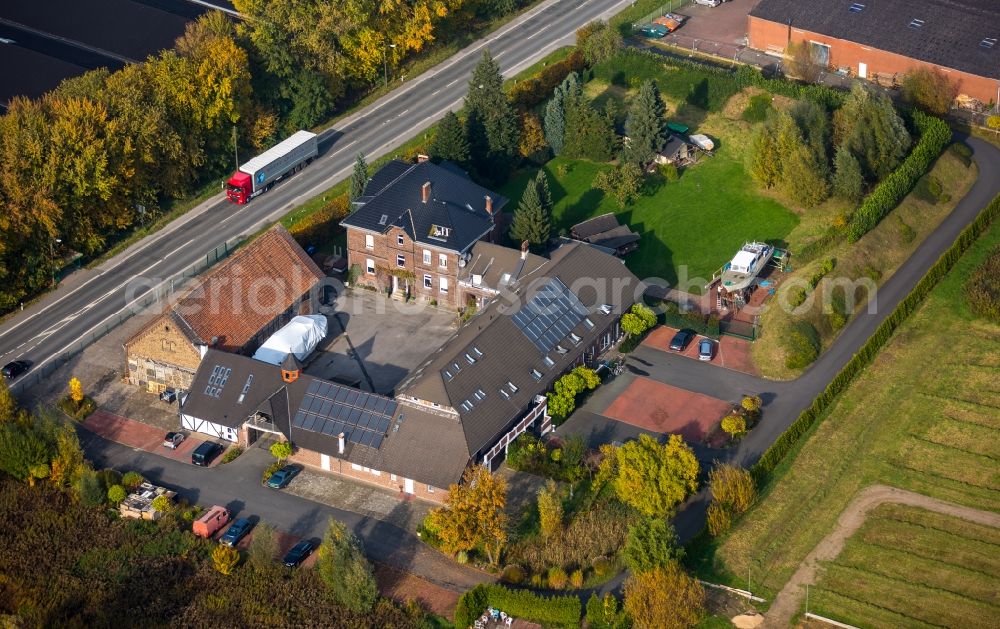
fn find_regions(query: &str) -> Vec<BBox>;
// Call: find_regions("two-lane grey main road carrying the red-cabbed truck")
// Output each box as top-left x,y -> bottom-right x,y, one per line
0,0 -> 630,390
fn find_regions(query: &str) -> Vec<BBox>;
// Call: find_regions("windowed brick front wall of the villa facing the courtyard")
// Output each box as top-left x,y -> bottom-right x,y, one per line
347,227 -> 460,307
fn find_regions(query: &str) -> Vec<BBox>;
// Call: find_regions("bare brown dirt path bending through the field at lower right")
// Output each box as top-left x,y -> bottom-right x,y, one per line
764,485 -> 1000,628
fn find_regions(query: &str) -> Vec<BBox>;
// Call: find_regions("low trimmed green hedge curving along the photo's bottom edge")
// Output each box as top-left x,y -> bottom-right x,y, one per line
455,583 -> 582,629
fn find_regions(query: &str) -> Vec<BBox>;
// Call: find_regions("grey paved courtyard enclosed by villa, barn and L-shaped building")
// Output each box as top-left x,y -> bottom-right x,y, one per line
306,289 -> 457,394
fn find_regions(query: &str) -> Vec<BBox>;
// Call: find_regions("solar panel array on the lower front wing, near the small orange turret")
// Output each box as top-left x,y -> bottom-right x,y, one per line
292,380 -> 397,449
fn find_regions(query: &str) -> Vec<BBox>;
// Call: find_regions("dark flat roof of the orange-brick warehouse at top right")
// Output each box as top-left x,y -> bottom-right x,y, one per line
750,0 -> 1000,78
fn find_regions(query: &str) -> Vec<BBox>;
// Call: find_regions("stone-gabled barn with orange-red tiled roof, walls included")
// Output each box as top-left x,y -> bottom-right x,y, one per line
124,225 -> 324,393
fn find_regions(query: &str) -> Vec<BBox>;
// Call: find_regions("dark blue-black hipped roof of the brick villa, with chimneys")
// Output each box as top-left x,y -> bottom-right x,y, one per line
341,161 -> 507,251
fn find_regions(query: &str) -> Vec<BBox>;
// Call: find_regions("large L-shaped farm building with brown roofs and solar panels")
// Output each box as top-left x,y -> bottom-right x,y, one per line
180,243 -> 643,502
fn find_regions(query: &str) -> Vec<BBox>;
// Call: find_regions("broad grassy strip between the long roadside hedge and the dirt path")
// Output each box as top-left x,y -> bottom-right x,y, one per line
699,224 -> 1000,592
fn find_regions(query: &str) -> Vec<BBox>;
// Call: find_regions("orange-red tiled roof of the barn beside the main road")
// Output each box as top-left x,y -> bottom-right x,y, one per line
164,225 -> 325,351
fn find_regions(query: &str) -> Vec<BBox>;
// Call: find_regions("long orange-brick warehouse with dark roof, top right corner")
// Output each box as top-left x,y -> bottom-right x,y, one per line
747,0 -> 1000,103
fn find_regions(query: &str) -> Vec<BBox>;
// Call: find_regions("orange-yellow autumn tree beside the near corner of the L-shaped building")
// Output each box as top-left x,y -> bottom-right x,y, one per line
430,465 -> 507,564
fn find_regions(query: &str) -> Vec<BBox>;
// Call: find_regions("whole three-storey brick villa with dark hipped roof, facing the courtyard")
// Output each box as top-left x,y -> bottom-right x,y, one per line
341,160 -> 507,307
